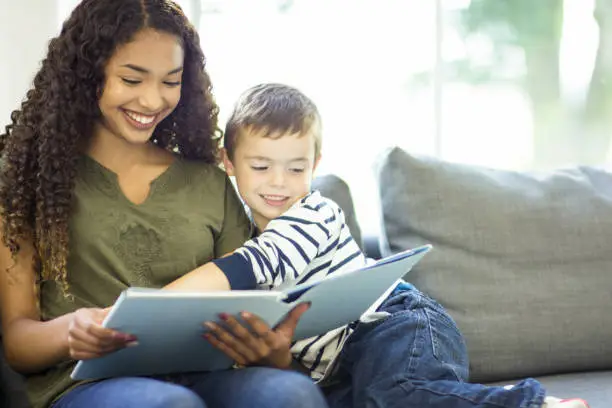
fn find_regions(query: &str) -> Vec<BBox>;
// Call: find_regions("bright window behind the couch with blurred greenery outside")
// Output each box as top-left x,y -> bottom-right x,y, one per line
62,0 -> 612,233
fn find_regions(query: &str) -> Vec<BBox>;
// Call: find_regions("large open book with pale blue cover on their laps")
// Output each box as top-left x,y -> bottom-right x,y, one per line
71,245 -> 431,380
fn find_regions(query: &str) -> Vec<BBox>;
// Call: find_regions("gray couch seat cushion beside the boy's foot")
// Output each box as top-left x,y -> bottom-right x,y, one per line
492,371 -> 612,408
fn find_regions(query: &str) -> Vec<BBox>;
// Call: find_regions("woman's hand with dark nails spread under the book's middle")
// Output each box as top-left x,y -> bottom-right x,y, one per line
202,303 -> 310,369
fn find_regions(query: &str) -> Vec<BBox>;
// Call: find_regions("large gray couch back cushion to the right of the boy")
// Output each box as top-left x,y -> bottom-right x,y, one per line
378,148 -> 612,381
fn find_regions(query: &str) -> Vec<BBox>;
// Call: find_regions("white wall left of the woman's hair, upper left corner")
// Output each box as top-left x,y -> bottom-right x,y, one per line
0,0 -> 59,132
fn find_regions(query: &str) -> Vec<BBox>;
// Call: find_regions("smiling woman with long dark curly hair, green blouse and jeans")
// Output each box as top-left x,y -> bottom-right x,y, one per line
0,0 -> 325,408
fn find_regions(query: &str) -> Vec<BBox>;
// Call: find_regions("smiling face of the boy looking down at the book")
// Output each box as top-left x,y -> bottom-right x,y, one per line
224,130 -> 318,230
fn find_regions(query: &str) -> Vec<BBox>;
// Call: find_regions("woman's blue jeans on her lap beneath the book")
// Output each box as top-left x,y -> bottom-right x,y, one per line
52,367 -> 327,408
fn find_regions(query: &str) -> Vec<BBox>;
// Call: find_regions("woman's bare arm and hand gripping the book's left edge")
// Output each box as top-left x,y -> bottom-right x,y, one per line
0,225 -> 135,374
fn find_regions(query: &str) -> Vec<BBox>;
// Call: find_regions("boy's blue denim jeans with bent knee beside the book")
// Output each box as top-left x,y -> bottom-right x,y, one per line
323,285 -> 544,408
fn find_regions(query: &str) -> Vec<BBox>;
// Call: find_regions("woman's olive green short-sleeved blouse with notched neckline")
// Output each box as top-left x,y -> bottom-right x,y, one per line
26,156 -> 250,408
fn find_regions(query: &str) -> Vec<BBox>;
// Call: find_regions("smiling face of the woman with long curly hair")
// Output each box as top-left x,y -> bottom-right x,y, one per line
98,29 -> 184,144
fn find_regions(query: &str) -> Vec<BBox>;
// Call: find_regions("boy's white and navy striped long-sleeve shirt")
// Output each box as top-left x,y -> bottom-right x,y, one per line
210,191 -> 382,380
